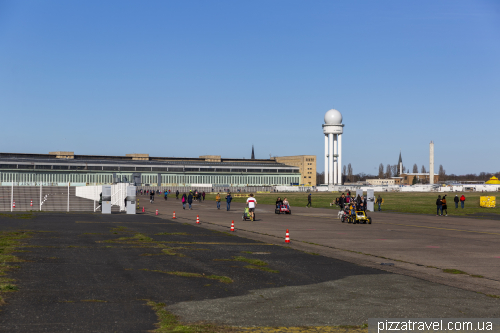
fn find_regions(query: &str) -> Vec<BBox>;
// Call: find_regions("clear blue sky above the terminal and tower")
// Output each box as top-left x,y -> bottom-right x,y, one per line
0,0 -> 500,174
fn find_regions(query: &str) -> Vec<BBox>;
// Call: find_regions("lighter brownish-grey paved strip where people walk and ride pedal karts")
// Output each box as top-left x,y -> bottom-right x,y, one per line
139,194 -> 500,296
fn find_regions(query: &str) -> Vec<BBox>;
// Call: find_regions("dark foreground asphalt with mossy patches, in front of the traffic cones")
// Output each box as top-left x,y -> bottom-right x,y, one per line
0,212 -> 500,332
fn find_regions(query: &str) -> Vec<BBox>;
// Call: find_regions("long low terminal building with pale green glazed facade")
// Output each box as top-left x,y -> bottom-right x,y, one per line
0,152 -> 301,188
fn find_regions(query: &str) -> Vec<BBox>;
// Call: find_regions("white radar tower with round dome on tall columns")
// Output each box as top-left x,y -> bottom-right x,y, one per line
323,109 -> 344,185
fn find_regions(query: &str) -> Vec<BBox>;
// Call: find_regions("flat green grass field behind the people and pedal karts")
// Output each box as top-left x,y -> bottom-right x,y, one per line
206,192 -> 500,216
